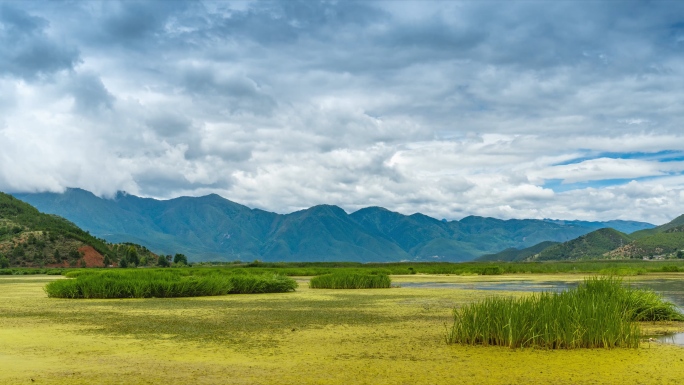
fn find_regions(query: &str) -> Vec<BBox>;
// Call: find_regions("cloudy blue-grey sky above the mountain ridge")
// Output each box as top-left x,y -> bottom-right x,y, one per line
0,0 -> 684,224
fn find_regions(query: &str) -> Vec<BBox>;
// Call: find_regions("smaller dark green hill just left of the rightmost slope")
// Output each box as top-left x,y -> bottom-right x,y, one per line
528,228 -> 632,261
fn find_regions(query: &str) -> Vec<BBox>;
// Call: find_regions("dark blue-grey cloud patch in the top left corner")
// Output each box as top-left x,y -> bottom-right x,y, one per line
0,3 -> 79,79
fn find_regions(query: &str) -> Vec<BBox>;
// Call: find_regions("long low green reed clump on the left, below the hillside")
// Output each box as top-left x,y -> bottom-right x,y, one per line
45,270 -> 297,298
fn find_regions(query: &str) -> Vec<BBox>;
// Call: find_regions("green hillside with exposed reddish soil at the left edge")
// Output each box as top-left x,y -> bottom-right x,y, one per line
0,193 -> 156,267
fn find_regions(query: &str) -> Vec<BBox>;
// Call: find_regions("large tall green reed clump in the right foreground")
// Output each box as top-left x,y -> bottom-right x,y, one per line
446,277 -> 682,349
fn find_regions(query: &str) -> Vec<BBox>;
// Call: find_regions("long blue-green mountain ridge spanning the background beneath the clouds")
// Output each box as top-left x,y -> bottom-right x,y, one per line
14,189 -> 654,262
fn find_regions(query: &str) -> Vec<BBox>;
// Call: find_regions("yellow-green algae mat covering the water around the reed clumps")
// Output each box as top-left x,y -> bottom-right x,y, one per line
0,275 -> 684,384
